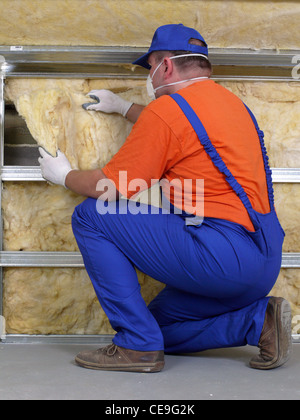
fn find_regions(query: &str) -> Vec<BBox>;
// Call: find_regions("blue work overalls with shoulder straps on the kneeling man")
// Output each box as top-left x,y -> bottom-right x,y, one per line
72,94 -> 284,353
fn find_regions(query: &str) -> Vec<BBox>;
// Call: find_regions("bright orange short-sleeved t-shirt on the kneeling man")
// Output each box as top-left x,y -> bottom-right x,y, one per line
103,80 -> 270,230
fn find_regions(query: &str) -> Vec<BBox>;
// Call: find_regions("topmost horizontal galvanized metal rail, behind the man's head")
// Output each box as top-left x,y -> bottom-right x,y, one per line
0,46 -> 299,81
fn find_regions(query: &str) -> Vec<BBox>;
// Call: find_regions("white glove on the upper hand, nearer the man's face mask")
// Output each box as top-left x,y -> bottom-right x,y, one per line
82,89 -> 133,117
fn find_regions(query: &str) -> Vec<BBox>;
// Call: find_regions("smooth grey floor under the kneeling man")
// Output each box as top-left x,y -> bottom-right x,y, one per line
0,343 -> 300,401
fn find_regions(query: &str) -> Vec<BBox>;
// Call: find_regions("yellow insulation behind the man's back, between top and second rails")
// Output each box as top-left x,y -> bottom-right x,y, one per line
222,82 -> 300,168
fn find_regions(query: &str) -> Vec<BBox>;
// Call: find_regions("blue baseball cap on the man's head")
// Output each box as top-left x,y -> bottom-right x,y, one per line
132,23 -> 208,70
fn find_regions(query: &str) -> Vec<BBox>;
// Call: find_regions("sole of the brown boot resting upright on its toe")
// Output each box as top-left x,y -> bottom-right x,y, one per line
250,298 -> 292,370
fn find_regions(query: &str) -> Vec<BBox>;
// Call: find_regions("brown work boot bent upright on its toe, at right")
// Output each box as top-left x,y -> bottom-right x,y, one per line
250,297 -> 292,370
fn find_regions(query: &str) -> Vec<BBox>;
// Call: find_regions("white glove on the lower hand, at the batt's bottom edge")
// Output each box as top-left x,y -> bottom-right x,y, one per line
38,147 -> 72,188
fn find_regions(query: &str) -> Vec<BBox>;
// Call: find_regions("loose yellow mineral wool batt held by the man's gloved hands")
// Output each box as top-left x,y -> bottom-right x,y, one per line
6,80 -> 149,170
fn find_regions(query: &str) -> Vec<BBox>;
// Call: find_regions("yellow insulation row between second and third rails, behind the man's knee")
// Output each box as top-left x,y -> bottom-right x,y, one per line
2,182 -> 300,252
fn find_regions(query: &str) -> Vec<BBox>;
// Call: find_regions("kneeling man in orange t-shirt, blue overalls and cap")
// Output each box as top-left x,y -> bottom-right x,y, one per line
39,24 -> 291,372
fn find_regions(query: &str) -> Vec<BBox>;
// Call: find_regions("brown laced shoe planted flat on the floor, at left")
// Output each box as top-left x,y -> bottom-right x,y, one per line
75,344 -> 165,372
